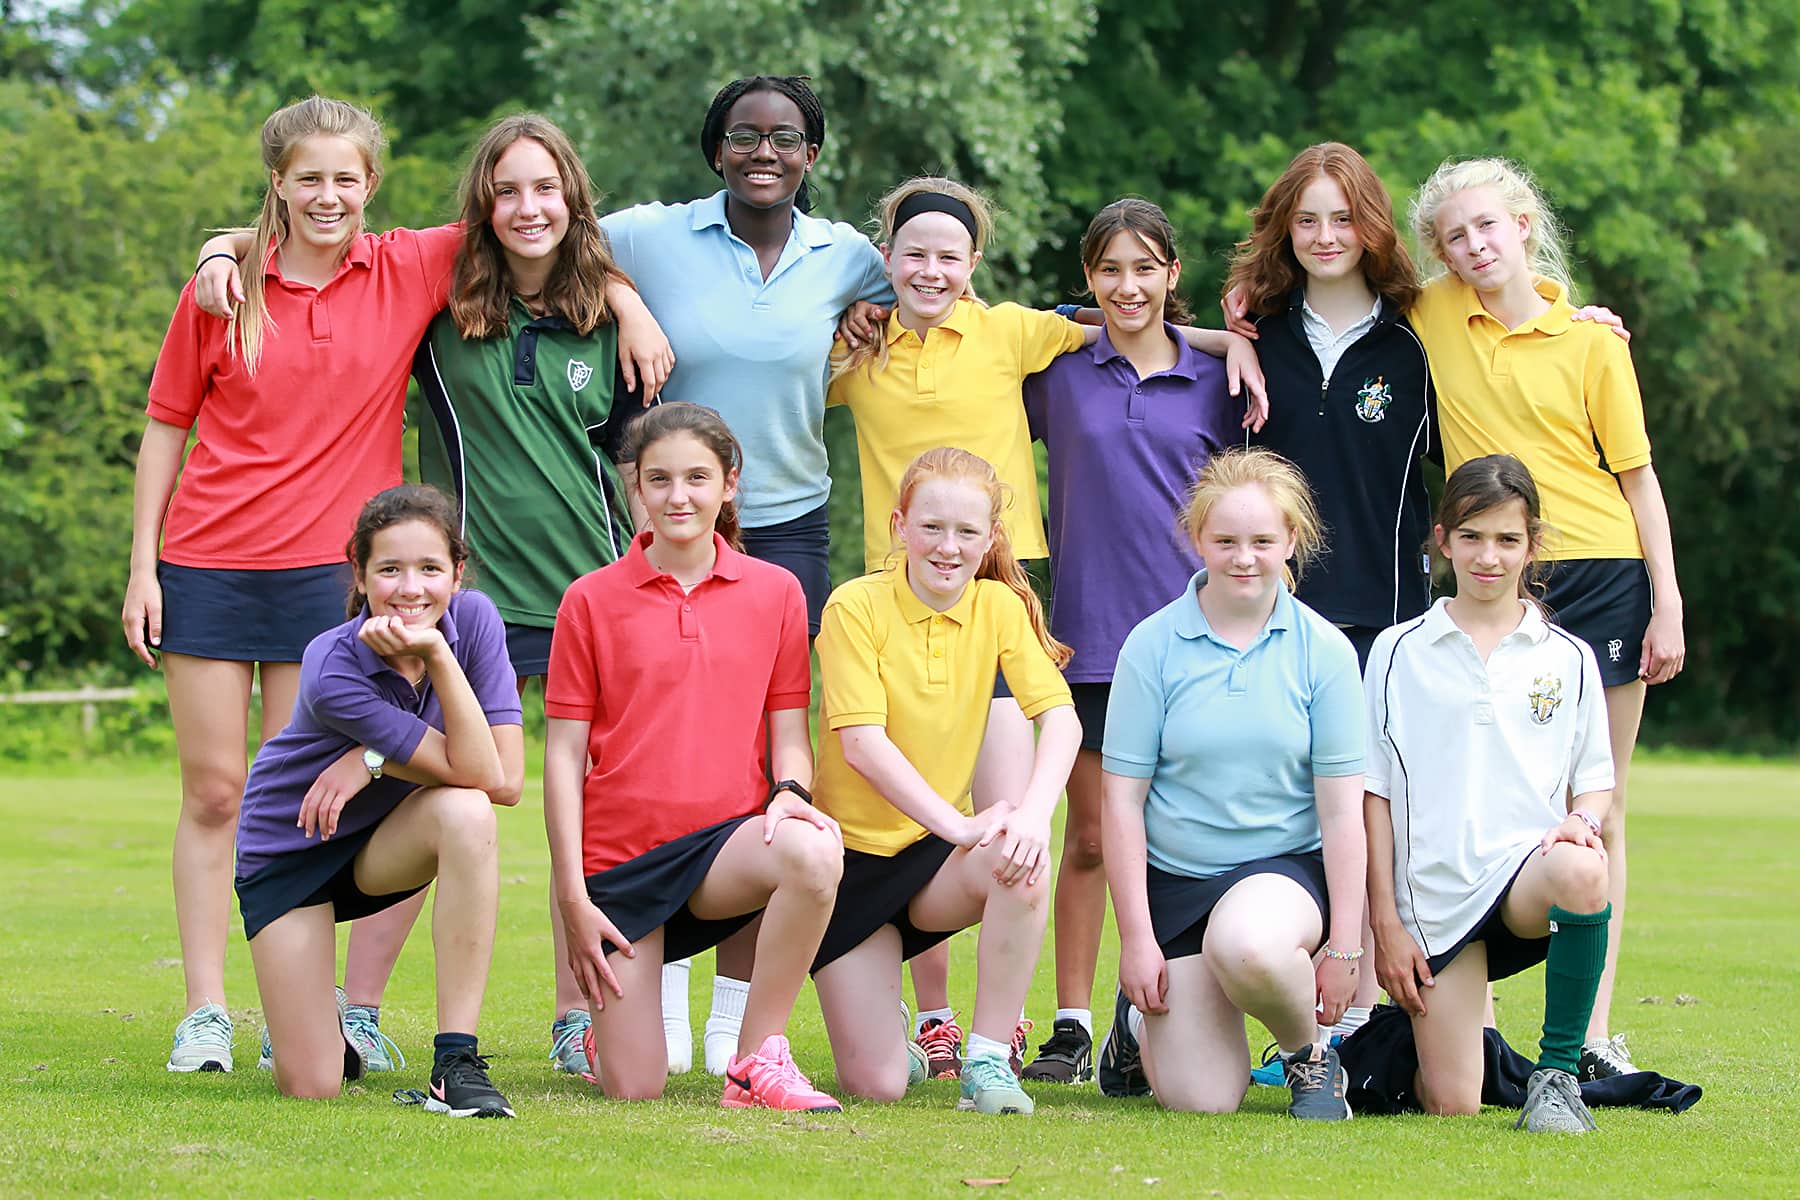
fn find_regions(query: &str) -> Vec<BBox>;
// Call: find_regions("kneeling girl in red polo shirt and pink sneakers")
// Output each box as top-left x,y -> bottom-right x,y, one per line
544,405 -> 844,1112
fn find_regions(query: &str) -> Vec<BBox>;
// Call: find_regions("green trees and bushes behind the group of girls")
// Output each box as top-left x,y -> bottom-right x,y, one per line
0,0 -> 1800,748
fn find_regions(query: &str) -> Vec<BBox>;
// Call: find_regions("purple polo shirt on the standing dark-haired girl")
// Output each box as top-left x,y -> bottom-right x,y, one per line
1024,324 -> 1244,684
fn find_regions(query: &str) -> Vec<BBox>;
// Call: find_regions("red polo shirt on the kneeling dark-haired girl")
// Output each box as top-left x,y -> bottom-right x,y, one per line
544,531 -> 812,874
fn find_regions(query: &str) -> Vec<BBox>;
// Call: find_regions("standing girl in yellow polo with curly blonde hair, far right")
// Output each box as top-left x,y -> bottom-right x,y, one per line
1411,158 -> 1687,1079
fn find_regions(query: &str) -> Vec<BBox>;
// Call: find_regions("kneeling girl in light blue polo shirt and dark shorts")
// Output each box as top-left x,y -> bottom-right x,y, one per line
1100,450 -> 1364,1121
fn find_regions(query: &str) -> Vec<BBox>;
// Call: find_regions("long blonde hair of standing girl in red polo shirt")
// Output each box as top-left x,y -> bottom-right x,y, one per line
227,95 -> 385,374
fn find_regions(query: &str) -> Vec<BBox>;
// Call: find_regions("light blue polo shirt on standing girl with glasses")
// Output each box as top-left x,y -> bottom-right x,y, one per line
601,191 -> 893,529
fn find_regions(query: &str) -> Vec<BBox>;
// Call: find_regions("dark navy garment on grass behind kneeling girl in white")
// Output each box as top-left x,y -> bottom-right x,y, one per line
1337,1004 -> 1701,1115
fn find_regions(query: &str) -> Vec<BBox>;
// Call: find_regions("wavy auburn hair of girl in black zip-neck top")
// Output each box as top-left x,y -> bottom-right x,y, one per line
1224,142 -> 1418,317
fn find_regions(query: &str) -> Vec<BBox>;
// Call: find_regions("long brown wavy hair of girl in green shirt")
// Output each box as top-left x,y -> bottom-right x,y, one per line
450,113 -> 625,338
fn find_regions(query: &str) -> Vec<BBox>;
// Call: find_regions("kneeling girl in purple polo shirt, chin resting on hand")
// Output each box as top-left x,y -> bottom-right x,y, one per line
238,486 -> 524,1117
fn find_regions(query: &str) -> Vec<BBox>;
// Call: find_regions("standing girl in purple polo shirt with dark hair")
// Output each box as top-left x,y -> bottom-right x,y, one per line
1022,198 -> 1242,1083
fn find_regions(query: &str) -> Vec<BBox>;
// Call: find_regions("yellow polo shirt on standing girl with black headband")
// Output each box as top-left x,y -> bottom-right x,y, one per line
826,297 -> 1082,570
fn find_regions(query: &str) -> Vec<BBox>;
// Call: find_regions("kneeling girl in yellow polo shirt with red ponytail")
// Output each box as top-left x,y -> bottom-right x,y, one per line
812,446 -> 1082,1112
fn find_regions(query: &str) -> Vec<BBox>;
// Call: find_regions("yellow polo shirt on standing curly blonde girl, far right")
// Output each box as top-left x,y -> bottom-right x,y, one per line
1409,275 -> 1651,560
